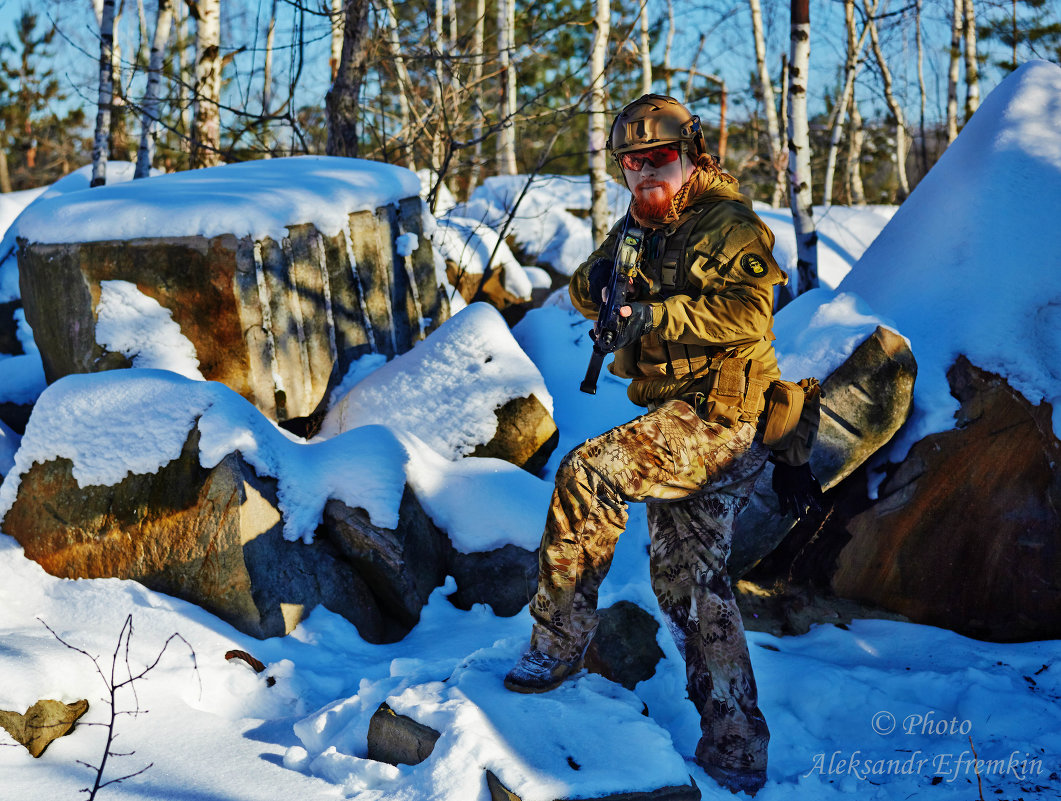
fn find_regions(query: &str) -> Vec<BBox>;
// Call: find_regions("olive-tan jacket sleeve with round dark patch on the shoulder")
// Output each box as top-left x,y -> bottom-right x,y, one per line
653,222 -> 786,346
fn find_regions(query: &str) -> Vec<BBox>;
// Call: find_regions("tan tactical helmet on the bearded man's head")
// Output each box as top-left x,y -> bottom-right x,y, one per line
606,94 -> 708,159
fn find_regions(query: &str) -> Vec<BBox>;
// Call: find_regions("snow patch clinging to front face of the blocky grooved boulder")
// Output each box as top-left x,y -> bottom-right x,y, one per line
95,281 -> 204,381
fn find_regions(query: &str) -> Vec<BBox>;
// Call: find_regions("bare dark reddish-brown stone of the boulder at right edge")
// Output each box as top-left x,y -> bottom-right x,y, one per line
833,356 -> 1061,641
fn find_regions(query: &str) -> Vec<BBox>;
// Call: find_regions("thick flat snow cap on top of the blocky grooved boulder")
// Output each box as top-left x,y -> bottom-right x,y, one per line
12,156 -> 420,243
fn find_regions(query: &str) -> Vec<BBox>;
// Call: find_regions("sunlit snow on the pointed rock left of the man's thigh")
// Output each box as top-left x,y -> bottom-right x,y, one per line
320,303 -> 553,459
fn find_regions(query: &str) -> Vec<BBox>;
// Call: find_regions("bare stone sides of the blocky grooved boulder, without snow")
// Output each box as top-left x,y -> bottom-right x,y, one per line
18,197 -> 449,421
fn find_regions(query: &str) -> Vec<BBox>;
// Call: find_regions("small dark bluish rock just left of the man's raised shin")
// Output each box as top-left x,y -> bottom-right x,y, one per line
447,542 -> 538,617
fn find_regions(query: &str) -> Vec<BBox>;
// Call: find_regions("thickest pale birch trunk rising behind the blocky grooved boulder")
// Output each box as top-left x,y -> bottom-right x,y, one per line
191,0 -> 222,170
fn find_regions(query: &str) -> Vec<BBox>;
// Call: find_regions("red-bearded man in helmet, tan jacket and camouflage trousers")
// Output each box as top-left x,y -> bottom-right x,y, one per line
505,94 -> 820,795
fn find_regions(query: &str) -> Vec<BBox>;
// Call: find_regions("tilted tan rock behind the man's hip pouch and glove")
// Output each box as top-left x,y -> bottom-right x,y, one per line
729,327 -> 918,576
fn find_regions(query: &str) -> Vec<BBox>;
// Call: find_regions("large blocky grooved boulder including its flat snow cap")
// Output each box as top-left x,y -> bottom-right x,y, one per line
15,157 -> 449,421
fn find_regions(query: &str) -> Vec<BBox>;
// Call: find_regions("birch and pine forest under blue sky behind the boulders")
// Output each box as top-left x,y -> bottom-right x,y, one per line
0,0 -> 1061,228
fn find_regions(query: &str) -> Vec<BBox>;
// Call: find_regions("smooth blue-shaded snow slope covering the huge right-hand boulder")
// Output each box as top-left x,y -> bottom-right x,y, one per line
838,62 -> 1061,459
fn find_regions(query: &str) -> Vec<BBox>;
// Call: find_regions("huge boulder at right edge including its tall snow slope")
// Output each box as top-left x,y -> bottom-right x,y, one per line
819,62 -> 1061,640
